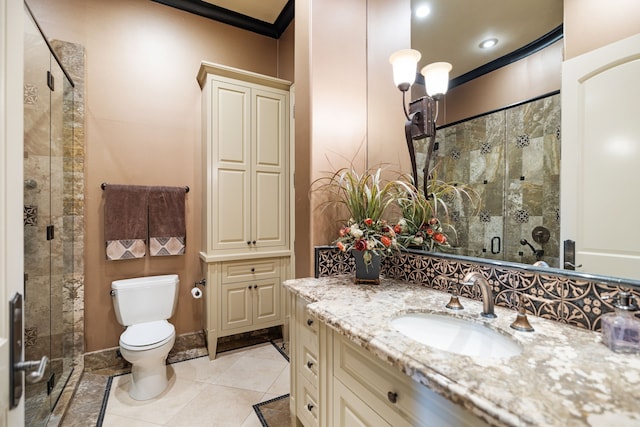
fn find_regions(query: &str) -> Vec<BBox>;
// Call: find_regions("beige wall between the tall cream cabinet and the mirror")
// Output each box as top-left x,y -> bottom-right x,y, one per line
295,0 -> 410,277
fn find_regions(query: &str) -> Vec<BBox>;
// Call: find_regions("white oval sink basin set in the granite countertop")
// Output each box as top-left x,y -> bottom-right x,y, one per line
391,313 -> 522,358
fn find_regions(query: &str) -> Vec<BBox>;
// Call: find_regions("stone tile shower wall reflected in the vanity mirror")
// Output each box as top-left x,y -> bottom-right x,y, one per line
424,94 -> 560,267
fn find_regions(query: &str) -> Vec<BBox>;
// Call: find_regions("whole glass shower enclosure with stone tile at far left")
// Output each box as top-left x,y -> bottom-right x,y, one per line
23,8 -> 74,426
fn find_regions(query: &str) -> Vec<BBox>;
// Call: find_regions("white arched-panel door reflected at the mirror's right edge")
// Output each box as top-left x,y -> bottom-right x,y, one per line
561,35 -> 640,279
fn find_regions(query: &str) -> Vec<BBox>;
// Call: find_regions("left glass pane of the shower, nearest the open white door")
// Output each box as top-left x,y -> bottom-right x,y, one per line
24,9 -> 51,426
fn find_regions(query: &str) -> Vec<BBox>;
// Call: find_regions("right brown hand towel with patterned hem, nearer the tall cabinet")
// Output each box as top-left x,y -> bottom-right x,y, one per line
149,187 -> 187,256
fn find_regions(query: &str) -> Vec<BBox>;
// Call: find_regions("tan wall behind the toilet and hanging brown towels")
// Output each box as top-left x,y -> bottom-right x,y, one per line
28,0 -> 293,351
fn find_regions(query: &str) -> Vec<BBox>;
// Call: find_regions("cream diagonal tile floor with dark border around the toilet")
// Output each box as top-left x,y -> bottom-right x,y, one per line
63,343 -> 290,427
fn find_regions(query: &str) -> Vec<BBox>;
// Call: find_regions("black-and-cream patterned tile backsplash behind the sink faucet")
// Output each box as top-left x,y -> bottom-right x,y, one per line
315,246 -> 640,331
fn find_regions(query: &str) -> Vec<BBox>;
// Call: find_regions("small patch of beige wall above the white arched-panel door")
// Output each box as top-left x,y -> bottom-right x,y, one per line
564,0 -> 640,60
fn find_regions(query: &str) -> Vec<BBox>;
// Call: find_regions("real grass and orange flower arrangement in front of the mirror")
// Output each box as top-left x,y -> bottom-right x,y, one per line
312,168 -> 408,266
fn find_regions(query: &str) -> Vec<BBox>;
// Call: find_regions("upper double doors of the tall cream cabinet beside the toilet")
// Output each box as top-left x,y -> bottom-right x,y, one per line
203,66 -> 290,255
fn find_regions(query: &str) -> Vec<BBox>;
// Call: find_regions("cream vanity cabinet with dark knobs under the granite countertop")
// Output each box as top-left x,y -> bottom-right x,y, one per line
289,293 -> 487,427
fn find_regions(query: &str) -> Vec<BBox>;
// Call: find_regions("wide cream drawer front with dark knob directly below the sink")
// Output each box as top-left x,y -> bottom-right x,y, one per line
334,334 -> 487,427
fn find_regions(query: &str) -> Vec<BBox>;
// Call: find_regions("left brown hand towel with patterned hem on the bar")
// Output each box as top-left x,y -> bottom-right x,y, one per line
104,184 -> 149,260
